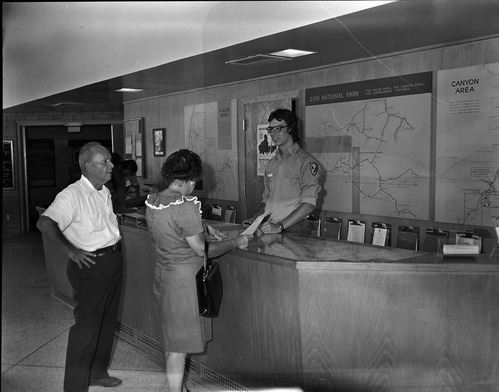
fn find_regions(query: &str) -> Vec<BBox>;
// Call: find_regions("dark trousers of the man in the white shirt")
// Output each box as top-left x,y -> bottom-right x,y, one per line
64,252 -> 123,392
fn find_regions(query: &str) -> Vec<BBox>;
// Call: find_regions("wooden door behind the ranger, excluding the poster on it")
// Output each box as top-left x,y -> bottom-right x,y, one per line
239,92 -> 298,221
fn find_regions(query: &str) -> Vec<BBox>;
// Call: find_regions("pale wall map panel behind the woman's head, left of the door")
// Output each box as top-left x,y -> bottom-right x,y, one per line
184,99 -> 239,200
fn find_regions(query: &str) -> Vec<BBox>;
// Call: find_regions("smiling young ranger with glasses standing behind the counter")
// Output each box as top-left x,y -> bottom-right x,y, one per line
243,109 -> 322,234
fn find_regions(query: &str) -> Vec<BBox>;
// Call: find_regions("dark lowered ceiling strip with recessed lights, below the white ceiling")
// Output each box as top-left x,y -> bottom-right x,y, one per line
4,0 -> 499,113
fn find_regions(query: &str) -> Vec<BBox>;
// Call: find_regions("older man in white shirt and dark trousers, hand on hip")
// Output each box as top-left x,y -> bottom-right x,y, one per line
37,142 -> 123,392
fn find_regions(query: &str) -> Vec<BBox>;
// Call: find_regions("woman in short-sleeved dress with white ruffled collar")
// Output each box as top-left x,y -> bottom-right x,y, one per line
146,149 -> 249,392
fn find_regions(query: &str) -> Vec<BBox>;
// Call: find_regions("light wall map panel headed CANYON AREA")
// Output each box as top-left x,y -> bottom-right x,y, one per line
435,63 -> 499,226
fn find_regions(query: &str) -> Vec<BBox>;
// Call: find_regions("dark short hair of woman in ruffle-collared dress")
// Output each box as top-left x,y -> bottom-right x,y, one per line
161,149 -> 203,186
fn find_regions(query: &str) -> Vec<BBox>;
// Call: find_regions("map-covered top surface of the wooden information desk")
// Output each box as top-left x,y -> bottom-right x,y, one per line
122,216 -> 499,273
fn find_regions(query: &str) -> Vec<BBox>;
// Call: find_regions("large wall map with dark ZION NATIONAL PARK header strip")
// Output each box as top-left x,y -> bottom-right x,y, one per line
304,72 -> 432,219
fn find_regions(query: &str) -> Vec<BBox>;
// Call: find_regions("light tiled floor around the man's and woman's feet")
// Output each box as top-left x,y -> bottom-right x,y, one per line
1,233 -> 219,392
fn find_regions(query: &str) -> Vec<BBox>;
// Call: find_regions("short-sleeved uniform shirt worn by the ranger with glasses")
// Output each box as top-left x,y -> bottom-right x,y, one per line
263,143 -> 321,223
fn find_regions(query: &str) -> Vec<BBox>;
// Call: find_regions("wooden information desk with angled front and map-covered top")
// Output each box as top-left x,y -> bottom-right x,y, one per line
40,216 -> 499,392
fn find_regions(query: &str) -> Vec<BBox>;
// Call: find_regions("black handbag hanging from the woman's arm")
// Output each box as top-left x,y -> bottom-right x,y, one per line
196,241 -> 223,317
